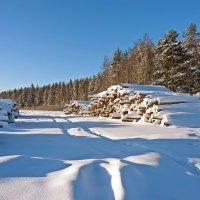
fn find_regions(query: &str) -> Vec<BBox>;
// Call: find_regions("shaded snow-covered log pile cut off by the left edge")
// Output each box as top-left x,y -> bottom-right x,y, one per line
0,99 -> 19,127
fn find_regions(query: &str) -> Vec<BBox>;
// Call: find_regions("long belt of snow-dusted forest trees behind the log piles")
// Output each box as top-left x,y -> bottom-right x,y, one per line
0,24 -> 200,109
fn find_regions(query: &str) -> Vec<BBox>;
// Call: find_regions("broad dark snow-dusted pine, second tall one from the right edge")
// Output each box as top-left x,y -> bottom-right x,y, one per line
154,30 -> 186,91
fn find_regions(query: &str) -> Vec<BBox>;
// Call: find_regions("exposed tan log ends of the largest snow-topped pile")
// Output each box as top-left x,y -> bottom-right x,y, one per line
88,84 -> 173,125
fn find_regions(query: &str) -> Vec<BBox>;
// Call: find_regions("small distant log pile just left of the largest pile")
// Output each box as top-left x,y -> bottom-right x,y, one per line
63,100 -> 90,115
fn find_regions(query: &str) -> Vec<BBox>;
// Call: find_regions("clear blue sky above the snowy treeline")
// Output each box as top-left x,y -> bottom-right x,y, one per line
0,0 -> 200,91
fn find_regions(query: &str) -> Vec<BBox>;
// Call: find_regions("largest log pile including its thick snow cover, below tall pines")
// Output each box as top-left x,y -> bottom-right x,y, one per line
88,84 -> 200,125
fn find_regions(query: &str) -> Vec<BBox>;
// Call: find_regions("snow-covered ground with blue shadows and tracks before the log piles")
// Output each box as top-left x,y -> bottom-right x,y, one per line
0,111 -> 200,200
